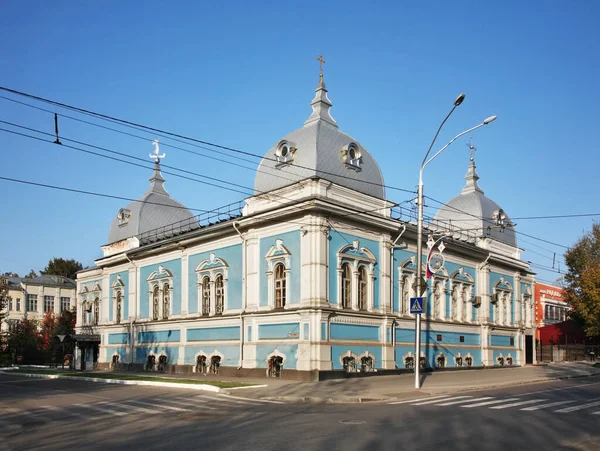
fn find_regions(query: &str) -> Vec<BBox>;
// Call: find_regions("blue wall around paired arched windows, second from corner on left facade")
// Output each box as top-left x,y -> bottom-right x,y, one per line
188,244 -> 244,313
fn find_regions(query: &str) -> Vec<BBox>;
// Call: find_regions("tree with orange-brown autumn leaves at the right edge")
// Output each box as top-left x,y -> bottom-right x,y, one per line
563,223 -> 600,336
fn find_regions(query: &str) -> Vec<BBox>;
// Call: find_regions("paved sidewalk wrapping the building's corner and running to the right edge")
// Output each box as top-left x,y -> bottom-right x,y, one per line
232,362 -> 600,403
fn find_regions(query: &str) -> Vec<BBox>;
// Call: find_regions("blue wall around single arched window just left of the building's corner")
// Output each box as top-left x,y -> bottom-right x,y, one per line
259,230 -> 301,306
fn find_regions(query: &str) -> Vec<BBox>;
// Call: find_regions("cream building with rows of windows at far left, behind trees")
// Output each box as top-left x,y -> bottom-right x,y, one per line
2,275 -> 76,331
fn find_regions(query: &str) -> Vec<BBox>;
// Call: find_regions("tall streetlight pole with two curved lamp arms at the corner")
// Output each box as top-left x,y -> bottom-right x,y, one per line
415,111 -> 496,389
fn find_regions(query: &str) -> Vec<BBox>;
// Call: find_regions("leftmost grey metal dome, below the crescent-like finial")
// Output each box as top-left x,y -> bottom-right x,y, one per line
108,163 -> 194,244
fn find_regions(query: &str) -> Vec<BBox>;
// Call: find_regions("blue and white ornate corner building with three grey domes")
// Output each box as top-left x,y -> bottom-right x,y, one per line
77,74 -> 535,379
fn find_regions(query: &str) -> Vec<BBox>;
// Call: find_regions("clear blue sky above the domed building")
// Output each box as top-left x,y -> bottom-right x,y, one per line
0,0 -> 600,286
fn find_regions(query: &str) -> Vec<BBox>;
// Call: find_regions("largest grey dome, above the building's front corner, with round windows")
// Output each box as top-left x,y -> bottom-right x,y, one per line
254,80 -> 385,199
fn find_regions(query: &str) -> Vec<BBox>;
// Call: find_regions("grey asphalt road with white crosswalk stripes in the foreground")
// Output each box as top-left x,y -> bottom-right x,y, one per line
0,375 -> 600,451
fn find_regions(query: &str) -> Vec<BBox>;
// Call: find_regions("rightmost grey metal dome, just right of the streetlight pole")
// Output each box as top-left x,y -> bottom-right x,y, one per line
434,158 -> 517,247
